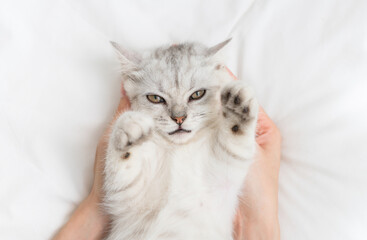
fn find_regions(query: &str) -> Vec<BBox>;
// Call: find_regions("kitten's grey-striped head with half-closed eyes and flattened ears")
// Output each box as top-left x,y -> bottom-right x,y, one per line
112,39 -> 230,143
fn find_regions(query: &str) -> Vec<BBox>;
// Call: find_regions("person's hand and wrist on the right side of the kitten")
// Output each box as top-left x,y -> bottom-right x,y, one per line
234,107 -> 281,240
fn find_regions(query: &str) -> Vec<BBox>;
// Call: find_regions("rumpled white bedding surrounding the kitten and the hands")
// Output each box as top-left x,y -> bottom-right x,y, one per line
0,0 -> 367,240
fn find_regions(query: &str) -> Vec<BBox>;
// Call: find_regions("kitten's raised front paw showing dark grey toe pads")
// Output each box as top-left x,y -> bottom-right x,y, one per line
221,81 -> 258,132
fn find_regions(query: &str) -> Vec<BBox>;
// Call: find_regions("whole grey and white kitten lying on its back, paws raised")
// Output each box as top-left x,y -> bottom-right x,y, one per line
104,40 -> 258,240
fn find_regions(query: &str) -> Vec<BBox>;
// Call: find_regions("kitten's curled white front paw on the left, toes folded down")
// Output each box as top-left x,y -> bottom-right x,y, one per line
112,111 -> 154,151
